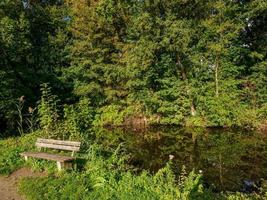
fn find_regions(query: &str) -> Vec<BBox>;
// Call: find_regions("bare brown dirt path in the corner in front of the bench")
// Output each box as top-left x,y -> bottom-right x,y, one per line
0,168 -> 45,200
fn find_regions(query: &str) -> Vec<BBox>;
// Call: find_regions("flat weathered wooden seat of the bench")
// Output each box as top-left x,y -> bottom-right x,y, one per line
20,152 -> 75,162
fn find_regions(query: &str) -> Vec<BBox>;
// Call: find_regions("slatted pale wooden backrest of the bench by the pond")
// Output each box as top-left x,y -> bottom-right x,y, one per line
36,138 -> 81,154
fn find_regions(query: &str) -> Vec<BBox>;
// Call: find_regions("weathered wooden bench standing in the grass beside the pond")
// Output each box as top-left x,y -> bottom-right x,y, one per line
20,138 -> 81,170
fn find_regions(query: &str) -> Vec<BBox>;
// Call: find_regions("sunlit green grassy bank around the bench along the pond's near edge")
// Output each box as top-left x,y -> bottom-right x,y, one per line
0,133 -> 267,200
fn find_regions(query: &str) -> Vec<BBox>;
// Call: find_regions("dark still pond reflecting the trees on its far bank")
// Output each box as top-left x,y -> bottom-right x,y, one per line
98,127 -> 267,192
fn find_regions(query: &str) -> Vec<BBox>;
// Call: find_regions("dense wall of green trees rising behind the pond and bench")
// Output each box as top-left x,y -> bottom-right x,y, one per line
0,0 -> 267,132
